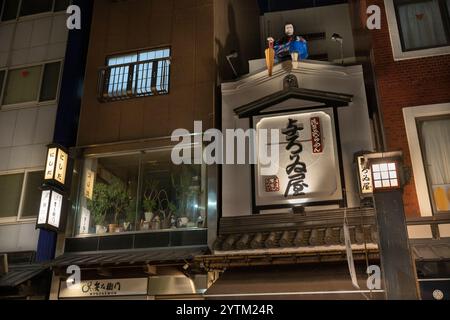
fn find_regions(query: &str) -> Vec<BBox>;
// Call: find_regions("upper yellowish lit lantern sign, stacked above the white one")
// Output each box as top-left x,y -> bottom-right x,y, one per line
44,144 -> 69,187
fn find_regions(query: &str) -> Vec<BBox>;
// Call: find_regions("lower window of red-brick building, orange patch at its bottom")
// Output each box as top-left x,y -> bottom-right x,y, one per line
418,116 -> 450,213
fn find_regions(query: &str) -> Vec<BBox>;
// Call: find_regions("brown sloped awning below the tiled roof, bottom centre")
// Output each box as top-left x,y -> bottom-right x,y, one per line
205,264 -> 384,300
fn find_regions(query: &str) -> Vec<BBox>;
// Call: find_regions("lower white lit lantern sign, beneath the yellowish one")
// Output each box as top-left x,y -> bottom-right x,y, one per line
36,188 -> 64,231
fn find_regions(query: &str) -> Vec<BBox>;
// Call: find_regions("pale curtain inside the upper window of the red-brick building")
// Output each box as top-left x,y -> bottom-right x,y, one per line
397,0 -> 447,50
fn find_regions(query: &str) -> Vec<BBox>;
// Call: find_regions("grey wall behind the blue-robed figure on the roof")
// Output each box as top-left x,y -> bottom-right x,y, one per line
261,4 -> 355,61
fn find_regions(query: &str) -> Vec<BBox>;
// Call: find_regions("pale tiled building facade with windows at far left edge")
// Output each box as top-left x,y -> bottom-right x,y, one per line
0,0 -> 69,298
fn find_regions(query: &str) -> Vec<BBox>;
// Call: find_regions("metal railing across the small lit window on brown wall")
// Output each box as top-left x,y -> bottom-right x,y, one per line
98,58 -> 170,102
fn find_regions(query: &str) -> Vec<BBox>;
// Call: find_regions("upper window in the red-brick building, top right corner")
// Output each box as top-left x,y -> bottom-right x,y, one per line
395,0 -> 450,51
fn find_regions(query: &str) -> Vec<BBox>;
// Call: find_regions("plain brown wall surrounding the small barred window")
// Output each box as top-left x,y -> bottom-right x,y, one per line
78,0 -> 215,145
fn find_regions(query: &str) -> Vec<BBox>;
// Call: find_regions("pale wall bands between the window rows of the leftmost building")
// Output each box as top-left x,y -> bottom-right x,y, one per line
0,12 -> 68,251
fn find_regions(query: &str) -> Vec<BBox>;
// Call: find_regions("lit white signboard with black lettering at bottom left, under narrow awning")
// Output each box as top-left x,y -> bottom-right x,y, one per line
59,278 -> 148,298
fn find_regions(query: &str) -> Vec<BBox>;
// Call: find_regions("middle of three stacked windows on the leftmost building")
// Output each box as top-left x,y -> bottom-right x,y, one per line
0,62 -> 61,105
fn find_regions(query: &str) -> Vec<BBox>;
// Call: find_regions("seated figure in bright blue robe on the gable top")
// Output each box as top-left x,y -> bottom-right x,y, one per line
267,23 -> 308,68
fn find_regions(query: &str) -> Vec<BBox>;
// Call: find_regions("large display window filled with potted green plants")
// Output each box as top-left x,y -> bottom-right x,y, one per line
76,149 -> 207,234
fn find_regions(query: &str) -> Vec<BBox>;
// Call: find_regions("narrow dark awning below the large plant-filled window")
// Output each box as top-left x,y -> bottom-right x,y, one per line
50,246 -> 209,267
